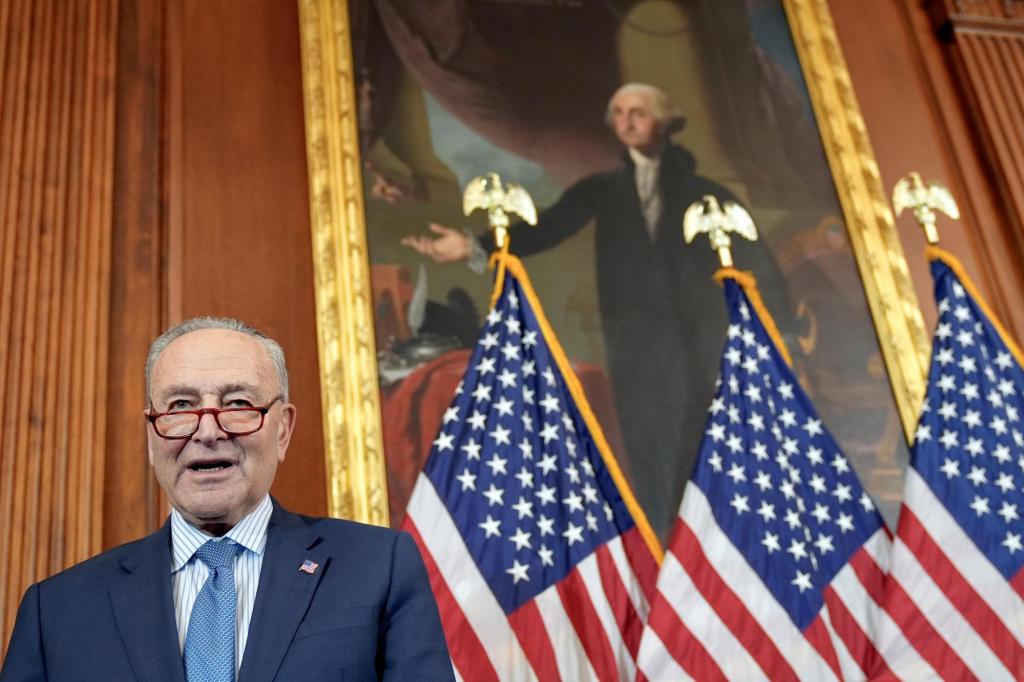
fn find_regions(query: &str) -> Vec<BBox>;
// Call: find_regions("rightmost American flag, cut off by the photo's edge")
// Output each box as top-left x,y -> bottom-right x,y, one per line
885,248 -> 1024,680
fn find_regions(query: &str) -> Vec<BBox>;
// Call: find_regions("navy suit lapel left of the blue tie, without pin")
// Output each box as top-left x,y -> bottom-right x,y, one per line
110,521 -> 184,682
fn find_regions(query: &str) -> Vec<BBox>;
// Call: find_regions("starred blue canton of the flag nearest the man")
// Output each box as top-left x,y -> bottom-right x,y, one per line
424,272 -> 634,613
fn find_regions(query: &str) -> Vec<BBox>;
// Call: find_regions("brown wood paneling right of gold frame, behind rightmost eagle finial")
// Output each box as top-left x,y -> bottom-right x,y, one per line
829,0 -> 1024,338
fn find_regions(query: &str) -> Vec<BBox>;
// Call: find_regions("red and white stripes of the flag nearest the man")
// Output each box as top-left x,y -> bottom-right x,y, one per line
404,474 -> 657,682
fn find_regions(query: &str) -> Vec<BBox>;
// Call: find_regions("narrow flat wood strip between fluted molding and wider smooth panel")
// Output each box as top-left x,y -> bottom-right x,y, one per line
103,0 -> 166,548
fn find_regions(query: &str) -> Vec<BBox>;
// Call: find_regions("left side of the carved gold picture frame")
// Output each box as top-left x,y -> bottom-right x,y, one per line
299,0 -> 388,525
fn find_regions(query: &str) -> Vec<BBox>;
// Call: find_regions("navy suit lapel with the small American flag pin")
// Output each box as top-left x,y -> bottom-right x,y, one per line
239,501 -> 331,682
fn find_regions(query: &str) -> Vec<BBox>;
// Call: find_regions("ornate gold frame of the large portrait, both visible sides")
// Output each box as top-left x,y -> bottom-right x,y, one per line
299,0 -> 929,525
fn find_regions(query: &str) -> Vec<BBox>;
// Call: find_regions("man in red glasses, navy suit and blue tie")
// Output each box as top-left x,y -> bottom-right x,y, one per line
0,317 -> 453,682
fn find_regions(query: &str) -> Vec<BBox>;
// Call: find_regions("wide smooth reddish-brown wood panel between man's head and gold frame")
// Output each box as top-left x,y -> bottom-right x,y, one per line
168,0 -> 327,514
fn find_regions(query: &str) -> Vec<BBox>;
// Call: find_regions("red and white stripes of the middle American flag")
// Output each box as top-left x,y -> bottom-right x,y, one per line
639,483 -> 889,680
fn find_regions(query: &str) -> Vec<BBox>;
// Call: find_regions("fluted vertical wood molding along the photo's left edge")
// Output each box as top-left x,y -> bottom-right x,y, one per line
0,0 -> 118,646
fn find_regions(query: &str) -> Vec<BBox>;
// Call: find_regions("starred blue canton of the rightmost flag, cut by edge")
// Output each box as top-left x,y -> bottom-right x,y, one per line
910,261 -> 1024,579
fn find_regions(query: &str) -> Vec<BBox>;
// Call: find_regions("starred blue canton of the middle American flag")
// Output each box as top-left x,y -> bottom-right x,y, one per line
693,280 -> 883,629
